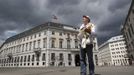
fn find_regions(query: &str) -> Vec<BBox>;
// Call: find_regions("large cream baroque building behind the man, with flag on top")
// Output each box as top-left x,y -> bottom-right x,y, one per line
0,22 -> 98,67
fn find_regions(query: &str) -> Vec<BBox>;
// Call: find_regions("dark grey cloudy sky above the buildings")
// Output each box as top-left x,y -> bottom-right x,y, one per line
0,0 -> 131,44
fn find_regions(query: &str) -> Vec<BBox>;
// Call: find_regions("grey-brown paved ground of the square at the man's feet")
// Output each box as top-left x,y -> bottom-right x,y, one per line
0,66 -> 134,75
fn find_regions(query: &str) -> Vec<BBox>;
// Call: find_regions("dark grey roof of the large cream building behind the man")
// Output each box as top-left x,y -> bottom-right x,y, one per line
0,22 -> 78,48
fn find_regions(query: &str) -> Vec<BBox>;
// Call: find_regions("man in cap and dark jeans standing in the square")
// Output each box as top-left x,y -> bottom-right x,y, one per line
78,15 -> 95,75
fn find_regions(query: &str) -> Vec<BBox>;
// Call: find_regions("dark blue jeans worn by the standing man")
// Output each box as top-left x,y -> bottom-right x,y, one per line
80,44 -> 94,75
